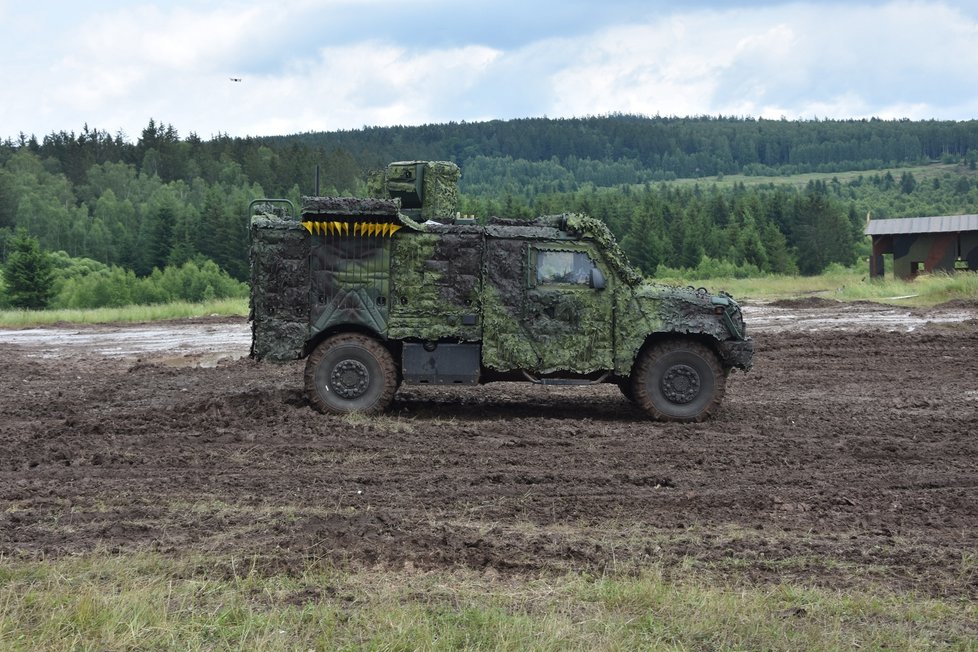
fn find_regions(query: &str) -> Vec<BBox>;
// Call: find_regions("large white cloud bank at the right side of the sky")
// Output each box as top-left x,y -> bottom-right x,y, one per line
549,2 -> 978,118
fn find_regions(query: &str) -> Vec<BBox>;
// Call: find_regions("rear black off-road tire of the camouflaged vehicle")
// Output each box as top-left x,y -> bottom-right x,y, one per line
305,333 -> 397,414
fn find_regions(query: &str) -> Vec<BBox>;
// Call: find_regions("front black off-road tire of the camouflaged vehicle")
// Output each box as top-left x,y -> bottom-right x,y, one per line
632,340 -> 727,421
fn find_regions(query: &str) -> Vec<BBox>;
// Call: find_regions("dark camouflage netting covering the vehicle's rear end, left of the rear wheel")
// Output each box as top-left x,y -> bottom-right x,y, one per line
251,215 -> 309,362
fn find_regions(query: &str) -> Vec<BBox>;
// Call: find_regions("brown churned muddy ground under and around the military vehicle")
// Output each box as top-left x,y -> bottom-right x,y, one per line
0,302 -> 978,598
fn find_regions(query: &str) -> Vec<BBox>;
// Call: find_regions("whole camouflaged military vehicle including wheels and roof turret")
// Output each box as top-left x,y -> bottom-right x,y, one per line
251,161 -> 753,421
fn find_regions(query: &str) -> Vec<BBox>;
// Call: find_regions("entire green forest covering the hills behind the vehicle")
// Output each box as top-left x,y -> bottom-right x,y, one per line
0,115 -> 978,307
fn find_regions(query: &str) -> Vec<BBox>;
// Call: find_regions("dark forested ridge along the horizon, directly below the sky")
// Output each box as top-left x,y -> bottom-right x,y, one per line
0,115 -> 978,196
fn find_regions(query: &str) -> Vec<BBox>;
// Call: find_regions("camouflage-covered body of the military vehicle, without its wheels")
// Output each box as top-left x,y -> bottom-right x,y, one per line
251,162 -> 752,378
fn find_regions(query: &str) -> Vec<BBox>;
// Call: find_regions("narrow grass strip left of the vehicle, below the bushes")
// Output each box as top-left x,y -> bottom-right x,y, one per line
0,298 -> 248,328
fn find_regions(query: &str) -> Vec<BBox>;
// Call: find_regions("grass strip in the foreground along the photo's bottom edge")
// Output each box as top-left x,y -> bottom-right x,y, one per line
0,553 -> 978,650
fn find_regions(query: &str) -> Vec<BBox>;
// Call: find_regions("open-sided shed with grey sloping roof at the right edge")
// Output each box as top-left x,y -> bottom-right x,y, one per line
866,215 -> 978,279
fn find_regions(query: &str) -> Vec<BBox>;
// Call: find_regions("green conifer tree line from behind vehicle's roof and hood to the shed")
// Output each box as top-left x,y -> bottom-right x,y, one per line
462,162 -> 978,278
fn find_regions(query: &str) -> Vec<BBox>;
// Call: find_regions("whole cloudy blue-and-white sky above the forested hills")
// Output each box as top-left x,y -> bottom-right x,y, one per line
0,0 -> 978,140
